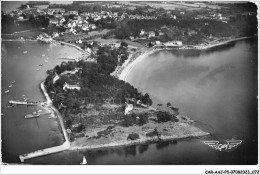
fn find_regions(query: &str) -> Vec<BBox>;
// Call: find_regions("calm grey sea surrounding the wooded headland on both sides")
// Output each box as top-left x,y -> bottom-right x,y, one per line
2,40 -> 258,165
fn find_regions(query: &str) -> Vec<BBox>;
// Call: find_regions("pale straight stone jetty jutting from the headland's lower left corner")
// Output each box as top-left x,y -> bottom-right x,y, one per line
19,141 -> 70,162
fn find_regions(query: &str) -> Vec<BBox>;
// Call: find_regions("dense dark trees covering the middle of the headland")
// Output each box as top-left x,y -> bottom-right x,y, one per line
45,46 -> 152,116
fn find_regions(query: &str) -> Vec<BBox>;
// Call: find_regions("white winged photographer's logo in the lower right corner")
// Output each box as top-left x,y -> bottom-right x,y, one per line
203,140 -> 243,152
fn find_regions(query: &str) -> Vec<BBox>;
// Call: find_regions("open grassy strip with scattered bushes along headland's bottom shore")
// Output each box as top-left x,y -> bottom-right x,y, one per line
69,120 -> 210,150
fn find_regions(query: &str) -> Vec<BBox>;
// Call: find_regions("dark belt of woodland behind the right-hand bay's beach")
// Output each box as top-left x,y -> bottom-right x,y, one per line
115,15 -> 257,40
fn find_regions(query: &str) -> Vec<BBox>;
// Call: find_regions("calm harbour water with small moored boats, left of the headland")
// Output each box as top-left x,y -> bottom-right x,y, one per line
1,41 -> 80,163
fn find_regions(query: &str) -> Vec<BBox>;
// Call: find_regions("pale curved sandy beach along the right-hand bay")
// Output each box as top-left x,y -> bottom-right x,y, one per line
116,37 -> 253,82
